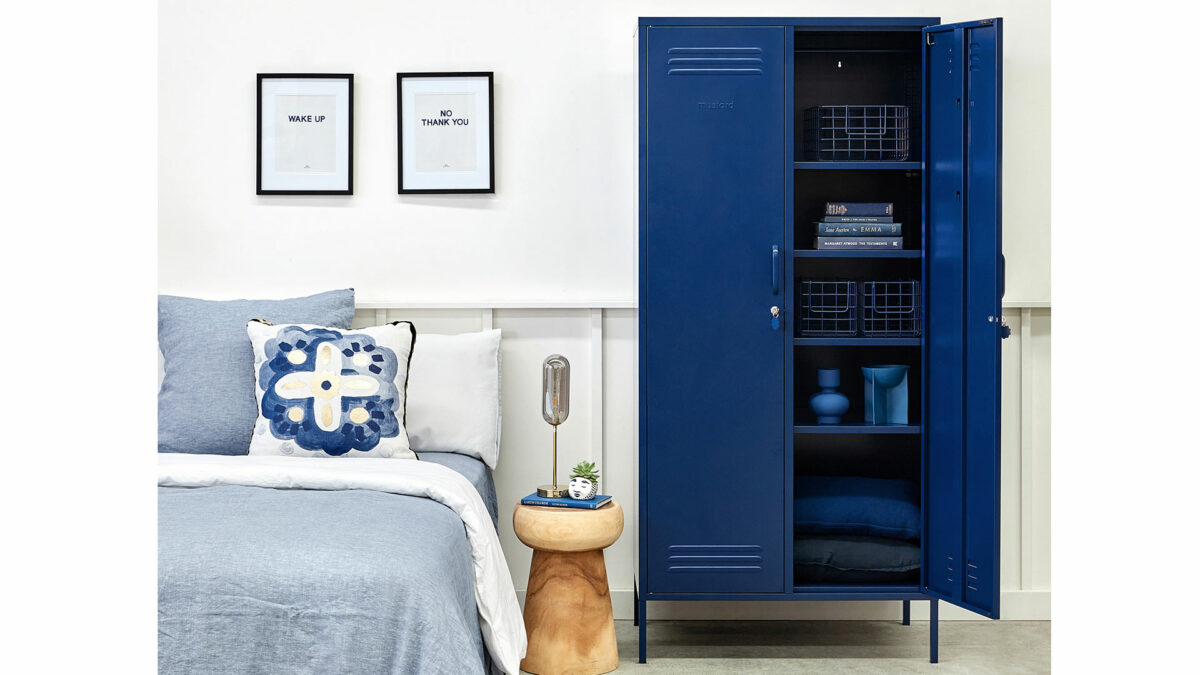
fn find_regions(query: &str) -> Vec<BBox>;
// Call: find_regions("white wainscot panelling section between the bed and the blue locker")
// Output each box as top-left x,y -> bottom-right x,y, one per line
354,303 -> 637,616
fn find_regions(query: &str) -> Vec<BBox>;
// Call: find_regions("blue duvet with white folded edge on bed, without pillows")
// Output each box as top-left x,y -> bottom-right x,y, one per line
158,453 -> 524,674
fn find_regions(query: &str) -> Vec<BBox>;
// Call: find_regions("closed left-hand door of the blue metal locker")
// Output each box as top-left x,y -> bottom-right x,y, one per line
638,26 -> 791,593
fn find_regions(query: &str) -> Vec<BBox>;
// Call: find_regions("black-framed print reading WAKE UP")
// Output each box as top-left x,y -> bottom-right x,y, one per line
257,73 -> 354,195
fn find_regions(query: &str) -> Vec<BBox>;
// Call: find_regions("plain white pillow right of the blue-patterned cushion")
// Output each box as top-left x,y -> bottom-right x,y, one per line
407,329 -> 500,468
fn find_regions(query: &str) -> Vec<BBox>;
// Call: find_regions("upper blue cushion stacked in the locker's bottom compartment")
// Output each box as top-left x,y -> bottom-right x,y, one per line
792,476 -> 920,539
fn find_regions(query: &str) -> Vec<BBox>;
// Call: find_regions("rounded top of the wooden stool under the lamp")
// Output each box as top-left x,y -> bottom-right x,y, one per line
512,500 -> 625,552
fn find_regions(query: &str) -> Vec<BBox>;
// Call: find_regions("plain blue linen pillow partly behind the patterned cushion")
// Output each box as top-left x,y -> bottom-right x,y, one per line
158,288 -> 354,455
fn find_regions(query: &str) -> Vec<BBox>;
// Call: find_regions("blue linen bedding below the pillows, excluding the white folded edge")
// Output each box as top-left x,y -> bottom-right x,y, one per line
158,454 -> 496,674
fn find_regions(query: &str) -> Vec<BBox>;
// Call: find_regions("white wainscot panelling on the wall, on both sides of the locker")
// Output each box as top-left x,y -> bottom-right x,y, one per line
354,303 -> 1050,620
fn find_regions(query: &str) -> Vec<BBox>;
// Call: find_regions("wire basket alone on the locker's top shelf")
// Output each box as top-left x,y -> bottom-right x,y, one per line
804,106 -> 908,162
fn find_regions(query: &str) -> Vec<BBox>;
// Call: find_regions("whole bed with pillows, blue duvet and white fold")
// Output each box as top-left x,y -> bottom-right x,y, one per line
158,288 -> 526,675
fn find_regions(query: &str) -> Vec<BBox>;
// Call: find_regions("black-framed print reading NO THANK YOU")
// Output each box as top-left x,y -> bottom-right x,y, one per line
396,72 -> 496,195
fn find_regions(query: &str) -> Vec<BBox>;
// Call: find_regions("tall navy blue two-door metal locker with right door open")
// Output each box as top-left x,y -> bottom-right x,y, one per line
635,13 -> 1007,662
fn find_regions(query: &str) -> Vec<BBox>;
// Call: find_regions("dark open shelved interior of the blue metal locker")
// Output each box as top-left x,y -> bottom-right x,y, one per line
792,30 -> 923,586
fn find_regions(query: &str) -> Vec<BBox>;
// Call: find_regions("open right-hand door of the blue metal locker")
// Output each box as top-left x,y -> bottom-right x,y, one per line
922,19 -> 1007,619
